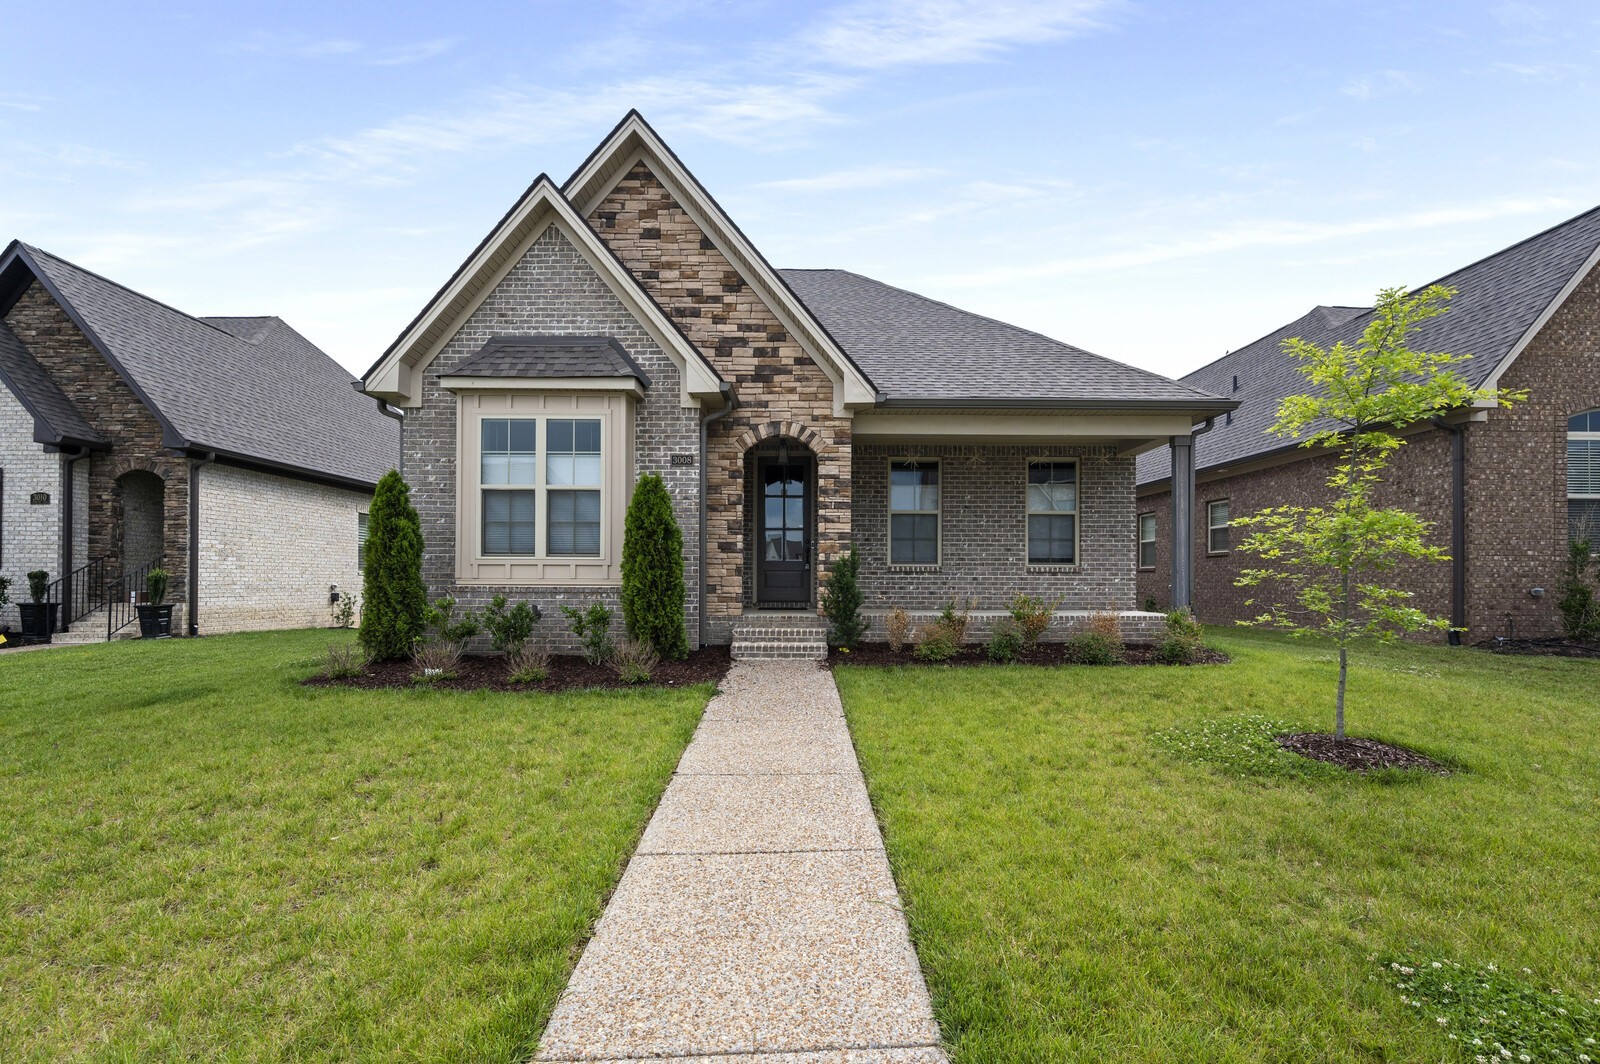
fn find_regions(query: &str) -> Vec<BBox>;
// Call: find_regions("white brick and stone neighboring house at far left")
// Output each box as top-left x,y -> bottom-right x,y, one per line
0,242 -> 400,640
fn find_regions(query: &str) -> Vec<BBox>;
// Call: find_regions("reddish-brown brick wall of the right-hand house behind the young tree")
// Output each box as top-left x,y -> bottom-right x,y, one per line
1138,262 -> 1600,642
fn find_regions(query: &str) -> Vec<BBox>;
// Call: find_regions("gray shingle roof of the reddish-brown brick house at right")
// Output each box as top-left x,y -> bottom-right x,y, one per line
1138,206 -> 1600,485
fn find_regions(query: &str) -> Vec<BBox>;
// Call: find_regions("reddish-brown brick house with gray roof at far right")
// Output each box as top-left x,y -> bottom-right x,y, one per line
1138,208 -> 1600,642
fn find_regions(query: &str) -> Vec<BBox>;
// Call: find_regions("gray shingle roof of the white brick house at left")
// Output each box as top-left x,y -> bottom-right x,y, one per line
0,242 -> 400,486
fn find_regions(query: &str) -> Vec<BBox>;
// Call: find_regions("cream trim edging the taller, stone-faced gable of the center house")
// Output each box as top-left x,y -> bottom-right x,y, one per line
562,110 -> 878,411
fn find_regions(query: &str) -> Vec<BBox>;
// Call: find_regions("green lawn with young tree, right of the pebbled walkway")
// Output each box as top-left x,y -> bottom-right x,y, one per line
835,632 -> 1600,1064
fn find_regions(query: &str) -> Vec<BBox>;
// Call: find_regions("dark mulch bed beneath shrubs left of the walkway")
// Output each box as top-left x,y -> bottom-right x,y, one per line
302,646 -> 730,694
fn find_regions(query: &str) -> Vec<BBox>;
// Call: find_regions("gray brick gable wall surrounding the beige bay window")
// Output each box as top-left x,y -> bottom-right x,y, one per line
402,226 -> 699,650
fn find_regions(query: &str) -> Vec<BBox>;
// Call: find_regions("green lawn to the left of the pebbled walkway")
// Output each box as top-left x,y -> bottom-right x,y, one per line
0,632 -> 710,1064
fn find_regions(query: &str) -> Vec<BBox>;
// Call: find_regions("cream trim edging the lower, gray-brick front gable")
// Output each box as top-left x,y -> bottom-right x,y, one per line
362,174 -> 723,406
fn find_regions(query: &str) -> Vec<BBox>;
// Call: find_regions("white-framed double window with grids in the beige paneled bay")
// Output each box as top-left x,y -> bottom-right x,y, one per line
478,418 -> 603,557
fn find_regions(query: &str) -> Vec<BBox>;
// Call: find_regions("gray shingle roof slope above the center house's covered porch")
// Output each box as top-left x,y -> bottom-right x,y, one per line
779,270 -> 1219,406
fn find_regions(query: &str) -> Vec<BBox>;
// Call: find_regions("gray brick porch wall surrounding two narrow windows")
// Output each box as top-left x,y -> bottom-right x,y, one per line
853,443 -> 1136,611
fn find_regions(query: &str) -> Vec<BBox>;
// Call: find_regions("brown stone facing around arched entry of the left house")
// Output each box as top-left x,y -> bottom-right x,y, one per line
5,282 -> 189,602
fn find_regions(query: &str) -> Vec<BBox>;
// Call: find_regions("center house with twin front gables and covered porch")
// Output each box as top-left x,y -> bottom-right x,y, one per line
363,112 -> 1234,643
